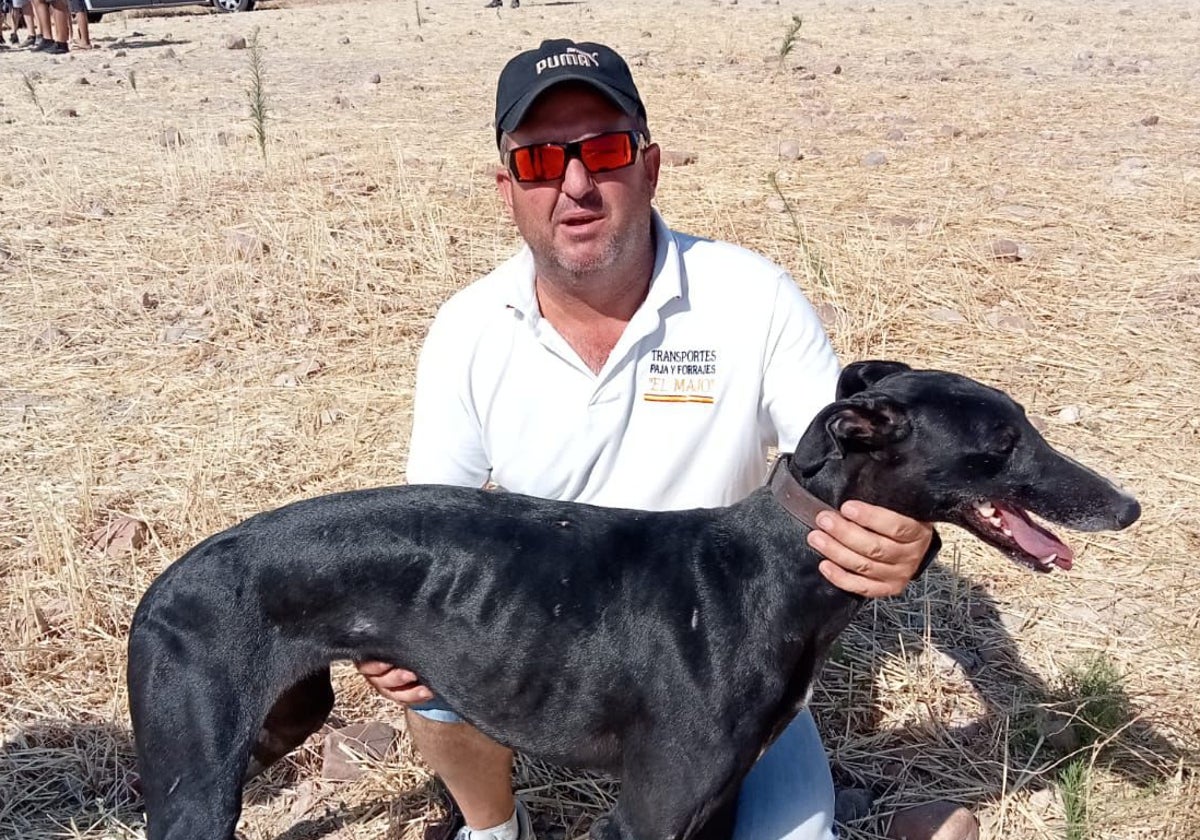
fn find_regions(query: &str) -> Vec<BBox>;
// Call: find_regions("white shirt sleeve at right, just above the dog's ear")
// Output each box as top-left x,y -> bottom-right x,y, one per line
761,272 -> 841,452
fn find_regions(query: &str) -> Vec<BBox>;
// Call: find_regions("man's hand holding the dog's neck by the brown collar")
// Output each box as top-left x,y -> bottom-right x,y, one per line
809,502 -> 934,598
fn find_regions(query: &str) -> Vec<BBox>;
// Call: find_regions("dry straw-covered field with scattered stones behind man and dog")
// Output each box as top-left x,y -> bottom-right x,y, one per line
0,0 -> 1200,840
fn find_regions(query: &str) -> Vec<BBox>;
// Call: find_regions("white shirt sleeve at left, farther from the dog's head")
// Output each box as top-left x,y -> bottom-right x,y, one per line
407,307 -> 491,487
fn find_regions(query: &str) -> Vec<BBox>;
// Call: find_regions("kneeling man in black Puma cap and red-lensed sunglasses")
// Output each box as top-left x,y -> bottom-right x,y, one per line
359,41 -> 932,840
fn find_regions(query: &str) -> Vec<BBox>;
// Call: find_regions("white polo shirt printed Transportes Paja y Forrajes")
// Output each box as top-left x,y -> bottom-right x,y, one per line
408,212 -> 839,510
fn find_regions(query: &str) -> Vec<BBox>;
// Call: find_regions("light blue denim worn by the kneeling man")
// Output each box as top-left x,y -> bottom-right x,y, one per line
409,698 -> 836,840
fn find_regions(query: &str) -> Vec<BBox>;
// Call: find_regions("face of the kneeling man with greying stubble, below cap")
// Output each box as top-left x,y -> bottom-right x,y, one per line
496,84 -> 659,277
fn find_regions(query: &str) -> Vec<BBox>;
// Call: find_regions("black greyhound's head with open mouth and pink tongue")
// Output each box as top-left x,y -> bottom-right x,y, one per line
793,361 -> 1141,571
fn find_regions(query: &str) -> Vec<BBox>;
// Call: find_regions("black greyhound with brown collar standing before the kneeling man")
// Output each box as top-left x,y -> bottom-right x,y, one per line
128,361 -> 1140,840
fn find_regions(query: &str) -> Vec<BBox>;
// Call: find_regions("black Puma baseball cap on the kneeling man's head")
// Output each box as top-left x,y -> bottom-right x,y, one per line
496,38 -> 646,145
